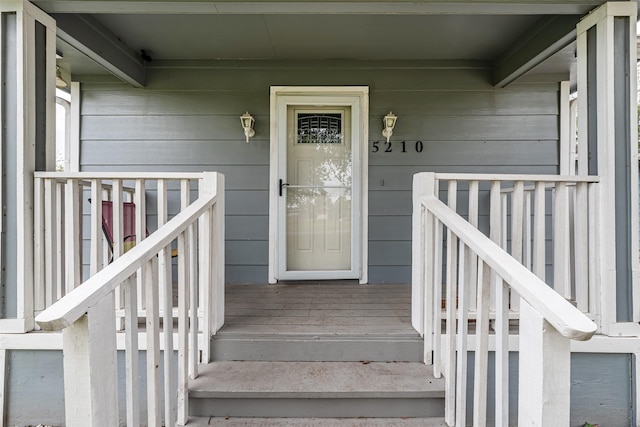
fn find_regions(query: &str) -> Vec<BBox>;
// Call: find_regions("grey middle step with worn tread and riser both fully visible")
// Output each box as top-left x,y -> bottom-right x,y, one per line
189,361 -> 444,418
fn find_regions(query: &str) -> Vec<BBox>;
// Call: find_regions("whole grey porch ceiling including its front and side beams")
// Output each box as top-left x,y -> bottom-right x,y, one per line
35,0 -> 632,85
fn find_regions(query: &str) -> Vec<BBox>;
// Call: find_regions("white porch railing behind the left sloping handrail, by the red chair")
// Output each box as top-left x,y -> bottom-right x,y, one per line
34,172 -> 203,326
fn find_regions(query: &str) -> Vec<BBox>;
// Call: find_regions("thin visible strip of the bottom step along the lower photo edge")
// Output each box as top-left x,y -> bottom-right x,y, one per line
188,417 -> 447,427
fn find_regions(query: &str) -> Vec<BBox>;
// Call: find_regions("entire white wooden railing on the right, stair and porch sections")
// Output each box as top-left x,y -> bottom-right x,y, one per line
413,173 -> 597,426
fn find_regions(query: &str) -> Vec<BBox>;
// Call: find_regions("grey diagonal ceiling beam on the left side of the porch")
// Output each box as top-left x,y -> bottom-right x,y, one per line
52,14 -> 147,87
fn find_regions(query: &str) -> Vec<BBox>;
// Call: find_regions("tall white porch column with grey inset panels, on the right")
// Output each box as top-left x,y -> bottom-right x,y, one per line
577,1 -> 640,335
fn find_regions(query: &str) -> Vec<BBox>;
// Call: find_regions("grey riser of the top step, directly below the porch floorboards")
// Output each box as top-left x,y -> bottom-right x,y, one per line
211,331 -> 424,362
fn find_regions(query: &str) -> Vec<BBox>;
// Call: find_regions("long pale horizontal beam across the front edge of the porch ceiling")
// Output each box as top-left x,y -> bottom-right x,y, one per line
33,0 -> 603,15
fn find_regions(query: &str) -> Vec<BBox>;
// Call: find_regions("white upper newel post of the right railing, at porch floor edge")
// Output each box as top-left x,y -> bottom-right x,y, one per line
411,172 -> 437,363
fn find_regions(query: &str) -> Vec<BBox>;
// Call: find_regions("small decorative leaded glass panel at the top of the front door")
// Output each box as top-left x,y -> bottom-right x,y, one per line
296,113 -> 343,144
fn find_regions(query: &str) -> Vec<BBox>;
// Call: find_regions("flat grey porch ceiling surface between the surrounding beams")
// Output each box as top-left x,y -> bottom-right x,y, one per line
69,14 -> 537,60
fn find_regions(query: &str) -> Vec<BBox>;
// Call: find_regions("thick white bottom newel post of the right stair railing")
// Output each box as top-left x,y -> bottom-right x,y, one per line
518,299 -> 571,427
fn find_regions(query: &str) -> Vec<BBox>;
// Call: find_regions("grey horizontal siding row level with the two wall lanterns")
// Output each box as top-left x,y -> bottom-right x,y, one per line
81,115 -> 558,143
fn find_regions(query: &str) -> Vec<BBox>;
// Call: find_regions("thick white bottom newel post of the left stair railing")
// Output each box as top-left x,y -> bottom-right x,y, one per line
62,293 -> 119,427
